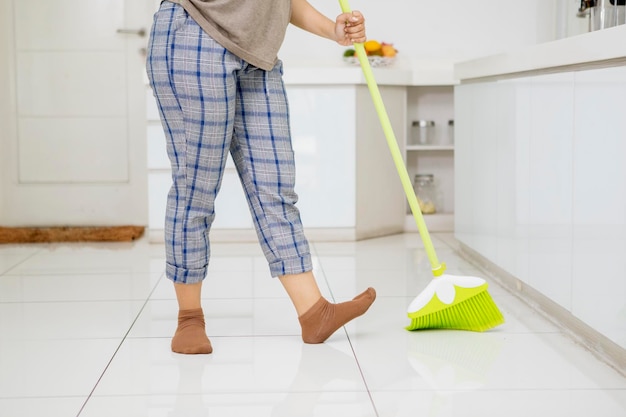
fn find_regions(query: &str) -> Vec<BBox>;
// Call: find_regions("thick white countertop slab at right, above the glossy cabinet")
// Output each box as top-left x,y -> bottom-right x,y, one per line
454,25 -> 626,81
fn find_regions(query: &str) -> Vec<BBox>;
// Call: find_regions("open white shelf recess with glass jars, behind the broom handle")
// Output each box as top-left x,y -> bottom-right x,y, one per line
404,86 -> 454,231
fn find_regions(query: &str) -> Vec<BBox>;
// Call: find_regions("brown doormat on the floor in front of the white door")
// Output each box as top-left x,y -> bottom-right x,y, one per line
0,226 -> 144,244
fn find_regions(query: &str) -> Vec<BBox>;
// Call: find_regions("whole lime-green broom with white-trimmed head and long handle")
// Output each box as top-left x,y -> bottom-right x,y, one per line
339,0 -> 504,331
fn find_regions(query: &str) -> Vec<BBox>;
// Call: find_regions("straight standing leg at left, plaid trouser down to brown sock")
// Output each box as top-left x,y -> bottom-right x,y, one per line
147,2 -> 241,353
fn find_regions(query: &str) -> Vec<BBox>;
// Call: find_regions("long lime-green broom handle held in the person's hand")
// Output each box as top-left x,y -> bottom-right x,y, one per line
339,0 -> 446,277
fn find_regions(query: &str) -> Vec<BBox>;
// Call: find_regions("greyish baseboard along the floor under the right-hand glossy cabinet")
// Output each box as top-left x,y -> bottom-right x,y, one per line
458,242 -> 626,376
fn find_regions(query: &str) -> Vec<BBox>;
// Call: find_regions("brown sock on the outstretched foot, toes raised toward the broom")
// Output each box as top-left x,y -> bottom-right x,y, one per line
298,288 -> 376,343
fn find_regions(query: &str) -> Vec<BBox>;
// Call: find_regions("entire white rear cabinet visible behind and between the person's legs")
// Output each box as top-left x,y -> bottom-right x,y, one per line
147,84 -> 406,240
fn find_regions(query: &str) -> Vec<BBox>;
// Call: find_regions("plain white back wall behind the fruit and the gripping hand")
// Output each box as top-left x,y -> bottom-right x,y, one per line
280,0 -> 560,63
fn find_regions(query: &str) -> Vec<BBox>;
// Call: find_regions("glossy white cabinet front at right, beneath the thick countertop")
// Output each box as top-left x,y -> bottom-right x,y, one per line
455,62 -> 626,350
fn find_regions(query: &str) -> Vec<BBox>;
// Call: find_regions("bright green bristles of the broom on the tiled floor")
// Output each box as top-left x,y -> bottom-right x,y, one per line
407,291 -> 504,332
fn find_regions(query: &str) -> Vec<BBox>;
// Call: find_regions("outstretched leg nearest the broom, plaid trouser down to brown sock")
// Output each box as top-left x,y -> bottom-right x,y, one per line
231,64 -> 376,343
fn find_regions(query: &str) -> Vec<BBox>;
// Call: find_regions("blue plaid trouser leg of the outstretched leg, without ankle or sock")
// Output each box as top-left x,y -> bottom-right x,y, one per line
230,60 -> 313,277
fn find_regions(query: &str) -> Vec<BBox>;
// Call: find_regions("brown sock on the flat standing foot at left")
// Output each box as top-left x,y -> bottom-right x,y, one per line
172,308 -> 213,355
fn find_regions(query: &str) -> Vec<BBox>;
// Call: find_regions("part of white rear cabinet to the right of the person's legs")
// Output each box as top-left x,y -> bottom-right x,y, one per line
287,84 -> 406,240
